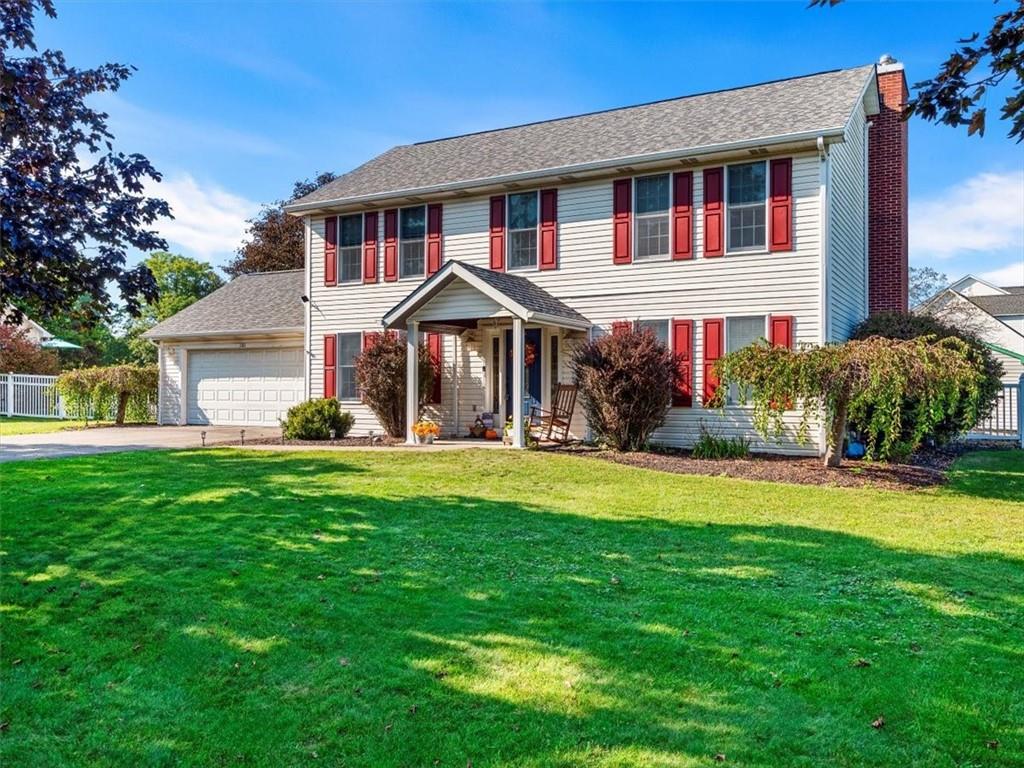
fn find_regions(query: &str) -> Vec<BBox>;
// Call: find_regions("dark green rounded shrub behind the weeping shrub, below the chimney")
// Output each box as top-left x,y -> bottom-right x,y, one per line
850,312 -> 1002,448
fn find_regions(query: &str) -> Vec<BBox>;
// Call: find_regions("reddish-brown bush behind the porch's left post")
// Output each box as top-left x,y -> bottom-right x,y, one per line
355,333 -> 434,437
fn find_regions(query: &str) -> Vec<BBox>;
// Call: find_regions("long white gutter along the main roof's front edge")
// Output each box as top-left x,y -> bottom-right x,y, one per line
285,126 -> 845,216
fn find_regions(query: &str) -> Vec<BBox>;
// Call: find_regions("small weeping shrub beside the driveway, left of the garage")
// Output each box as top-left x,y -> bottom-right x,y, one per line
55,366 -> 159,425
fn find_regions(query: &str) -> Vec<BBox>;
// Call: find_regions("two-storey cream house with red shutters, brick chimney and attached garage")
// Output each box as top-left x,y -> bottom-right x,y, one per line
148,56 -> 907,453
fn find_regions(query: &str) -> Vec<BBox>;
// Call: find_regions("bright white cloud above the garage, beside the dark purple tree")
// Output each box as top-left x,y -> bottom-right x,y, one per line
145,173 -> 259,260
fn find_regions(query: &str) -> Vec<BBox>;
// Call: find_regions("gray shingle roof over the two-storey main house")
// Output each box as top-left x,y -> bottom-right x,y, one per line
291,66 -> 874,206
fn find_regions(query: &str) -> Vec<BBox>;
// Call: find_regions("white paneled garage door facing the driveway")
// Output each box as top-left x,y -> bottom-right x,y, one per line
186,347 -> 303,427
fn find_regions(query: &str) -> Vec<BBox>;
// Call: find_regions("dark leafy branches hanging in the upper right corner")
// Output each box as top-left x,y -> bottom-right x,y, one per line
810,0 -> 1024,141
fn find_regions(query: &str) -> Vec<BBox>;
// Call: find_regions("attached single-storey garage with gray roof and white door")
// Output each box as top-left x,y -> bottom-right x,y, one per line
145,270 -> 306,427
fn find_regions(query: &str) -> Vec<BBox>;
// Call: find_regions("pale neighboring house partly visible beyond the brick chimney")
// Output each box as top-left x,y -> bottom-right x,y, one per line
914,274 -> 1024,384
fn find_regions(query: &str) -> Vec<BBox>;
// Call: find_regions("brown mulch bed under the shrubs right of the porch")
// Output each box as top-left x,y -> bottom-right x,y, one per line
563,443 -> 1005,490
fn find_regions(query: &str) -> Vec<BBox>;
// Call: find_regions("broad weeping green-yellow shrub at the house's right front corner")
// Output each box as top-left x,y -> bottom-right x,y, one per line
711,336 -> 983,467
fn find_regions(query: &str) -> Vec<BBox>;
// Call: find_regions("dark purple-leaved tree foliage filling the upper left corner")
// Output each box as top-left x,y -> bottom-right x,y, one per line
0,0 -> 170,316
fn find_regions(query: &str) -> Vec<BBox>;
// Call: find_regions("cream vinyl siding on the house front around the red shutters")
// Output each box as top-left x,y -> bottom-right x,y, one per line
309,153 -> 821,453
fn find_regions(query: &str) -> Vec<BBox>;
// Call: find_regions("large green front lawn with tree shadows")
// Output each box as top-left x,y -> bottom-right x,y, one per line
0,450 -> 1024,768
